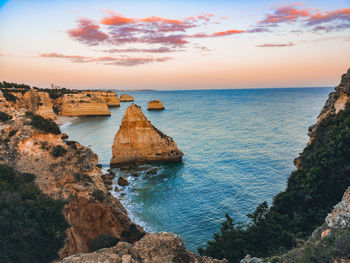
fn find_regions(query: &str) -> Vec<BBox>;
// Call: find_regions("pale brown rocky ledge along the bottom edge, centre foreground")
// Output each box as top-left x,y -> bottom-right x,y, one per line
61,232 -> 227,263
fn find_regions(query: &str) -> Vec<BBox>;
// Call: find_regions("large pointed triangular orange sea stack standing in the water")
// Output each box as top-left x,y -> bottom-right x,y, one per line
111,103 -> 183,166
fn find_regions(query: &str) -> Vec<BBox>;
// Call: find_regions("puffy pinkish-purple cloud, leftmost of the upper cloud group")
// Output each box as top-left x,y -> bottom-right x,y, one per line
68,18 -> 109,45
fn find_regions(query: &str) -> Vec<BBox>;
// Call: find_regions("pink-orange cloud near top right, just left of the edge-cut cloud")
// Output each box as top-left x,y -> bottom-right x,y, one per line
259,4 -> 310,25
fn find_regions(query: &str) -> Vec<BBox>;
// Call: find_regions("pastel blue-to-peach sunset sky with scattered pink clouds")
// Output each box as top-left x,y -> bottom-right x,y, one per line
0,0 -> 350,90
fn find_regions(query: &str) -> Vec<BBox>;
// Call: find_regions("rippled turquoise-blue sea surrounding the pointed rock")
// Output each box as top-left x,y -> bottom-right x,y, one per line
62,88 -> 331,251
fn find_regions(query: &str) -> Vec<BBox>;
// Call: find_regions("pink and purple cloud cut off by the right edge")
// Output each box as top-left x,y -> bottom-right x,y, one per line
307,8 -> 350,25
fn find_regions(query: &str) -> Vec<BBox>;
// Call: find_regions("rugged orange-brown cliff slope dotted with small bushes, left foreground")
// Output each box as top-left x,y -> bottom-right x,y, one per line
0,106 -> 143,258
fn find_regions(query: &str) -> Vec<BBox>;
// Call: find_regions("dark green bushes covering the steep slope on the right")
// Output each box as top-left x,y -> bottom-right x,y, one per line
198,104 -> 350,262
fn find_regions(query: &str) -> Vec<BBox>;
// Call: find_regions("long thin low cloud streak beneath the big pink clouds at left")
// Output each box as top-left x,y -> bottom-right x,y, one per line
40,53 -> 172,67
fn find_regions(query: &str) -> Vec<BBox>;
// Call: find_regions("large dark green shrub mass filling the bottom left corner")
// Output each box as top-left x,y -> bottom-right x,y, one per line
0,165 -> 69,263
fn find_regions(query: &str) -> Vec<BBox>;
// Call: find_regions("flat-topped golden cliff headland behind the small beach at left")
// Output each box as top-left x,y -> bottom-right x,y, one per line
54,92 -> 111,117
